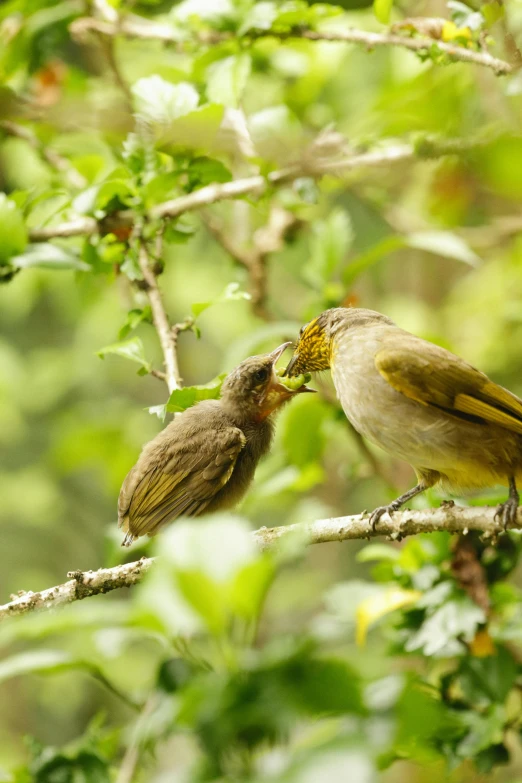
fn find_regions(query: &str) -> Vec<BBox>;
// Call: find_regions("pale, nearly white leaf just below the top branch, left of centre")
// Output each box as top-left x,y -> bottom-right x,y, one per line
131,75 -> 199,125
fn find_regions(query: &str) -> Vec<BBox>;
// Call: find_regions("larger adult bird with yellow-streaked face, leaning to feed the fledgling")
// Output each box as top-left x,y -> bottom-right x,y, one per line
285,307 -> 522,530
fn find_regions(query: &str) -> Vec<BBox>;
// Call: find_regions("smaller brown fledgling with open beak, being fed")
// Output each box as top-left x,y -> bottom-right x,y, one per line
118,342 -> 314,547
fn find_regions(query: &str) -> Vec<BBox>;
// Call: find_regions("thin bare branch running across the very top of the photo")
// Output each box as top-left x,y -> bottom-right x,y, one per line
70,15 -> 514,75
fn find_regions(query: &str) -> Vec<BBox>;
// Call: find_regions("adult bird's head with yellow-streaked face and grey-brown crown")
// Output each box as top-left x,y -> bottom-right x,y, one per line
285,307 -> 393,376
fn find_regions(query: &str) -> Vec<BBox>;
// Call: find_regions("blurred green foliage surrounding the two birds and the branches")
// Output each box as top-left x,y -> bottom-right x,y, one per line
0,0 -> 522,783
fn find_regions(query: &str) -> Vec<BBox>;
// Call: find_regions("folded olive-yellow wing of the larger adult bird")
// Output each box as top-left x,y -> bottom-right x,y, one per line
375,335 -> 522,434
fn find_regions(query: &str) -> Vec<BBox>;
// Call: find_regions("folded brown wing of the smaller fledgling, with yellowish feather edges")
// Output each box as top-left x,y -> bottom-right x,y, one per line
119,427 -> 246,537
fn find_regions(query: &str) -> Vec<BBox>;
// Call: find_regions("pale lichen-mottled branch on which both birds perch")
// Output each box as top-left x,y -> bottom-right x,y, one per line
0,502 -> 512,622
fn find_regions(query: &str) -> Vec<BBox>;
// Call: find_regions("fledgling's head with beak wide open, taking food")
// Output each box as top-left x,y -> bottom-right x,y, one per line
221,343 -> 313,421
